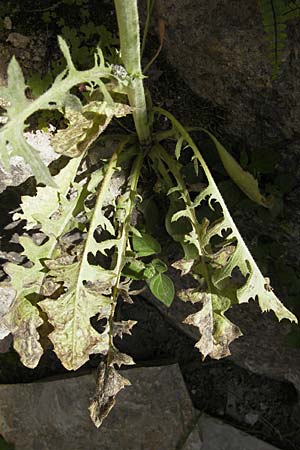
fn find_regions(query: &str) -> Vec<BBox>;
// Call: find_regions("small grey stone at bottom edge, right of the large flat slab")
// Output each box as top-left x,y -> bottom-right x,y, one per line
198,414 -> 279,450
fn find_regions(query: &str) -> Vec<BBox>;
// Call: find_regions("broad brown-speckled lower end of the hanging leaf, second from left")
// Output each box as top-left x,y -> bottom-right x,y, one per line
40,259 -> 115,370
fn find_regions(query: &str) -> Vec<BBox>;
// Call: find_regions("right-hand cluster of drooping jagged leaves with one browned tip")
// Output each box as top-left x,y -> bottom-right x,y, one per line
151,108 -> 296,358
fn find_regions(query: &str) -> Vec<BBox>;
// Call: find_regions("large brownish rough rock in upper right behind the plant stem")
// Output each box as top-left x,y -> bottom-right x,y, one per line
160,0 -> 300,149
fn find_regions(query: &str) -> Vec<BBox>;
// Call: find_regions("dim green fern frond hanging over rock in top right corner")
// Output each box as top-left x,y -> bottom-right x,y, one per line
258,0 -> 300,78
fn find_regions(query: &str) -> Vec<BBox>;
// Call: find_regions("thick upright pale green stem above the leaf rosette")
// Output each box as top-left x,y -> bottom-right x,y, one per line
115,0 -> 151,145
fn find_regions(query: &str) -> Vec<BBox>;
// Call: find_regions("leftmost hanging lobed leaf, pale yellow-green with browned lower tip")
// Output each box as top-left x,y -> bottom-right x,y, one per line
2,158 -> 81,368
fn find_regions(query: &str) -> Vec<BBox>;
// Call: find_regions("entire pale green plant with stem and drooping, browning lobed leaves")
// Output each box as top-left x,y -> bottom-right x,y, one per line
0,0 -> 296,426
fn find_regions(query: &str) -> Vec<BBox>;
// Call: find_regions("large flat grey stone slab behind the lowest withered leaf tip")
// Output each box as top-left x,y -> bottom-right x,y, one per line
0,365 -> 201,450
